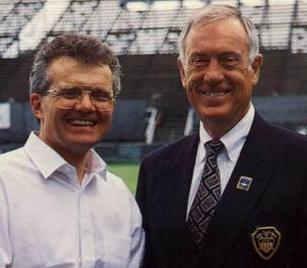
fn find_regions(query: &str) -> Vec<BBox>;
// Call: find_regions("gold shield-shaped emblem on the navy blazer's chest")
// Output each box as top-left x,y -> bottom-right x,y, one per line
252,226 -> 281,260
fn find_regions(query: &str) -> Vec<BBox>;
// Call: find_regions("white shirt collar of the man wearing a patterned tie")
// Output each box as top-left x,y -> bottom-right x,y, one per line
199,103 -> 255,162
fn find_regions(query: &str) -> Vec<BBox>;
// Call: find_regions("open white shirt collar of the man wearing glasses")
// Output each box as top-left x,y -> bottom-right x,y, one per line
24,131 -> 106,180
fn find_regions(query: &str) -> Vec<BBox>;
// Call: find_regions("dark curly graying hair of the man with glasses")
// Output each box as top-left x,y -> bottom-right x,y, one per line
29,33 -> 121,96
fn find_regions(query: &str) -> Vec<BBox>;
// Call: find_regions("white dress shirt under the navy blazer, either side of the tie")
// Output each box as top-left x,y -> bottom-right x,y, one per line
186,104 -> 255,217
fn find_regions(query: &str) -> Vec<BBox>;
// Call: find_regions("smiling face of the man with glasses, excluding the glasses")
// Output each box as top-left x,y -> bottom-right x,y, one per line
30,56 -> 113,158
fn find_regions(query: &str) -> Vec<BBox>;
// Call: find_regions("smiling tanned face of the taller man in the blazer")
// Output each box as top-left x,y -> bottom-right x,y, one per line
178,19 -> 262,136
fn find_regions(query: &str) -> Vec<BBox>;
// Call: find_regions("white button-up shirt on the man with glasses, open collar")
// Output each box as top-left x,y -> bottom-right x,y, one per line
0,133 -> 144,268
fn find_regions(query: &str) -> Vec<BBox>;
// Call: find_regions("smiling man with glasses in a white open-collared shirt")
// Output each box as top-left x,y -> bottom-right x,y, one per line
0,34 -> 144,268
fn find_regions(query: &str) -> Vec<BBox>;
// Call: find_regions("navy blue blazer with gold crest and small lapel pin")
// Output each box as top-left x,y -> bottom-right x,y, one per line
136,113 -> 307,268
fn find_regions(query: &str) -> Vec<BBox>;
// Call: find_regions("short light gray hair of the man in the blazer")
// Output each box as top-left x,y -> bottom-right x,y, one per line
178,5 -> 259,62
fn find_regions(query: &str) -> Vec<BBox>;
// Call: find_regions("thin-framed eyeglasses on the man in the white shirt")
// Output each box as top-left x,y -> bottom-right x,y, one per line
46,88 -> 115,111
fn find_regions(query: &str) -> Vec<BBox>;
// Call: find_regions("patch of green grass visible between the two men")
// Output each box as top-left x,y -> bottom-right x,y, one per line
109,163 -> 139,194
